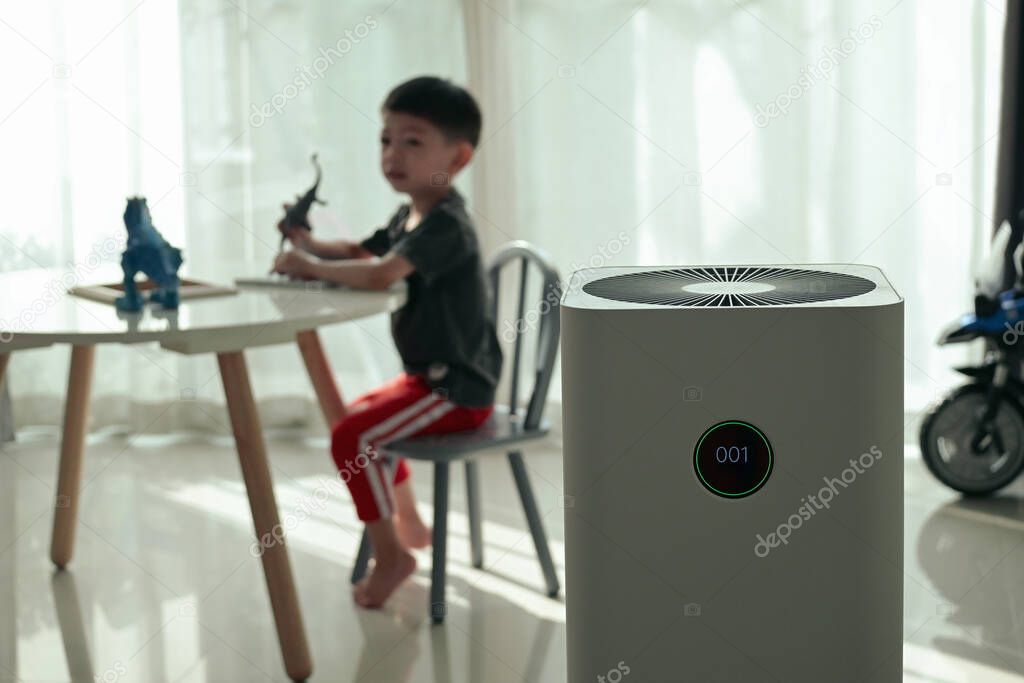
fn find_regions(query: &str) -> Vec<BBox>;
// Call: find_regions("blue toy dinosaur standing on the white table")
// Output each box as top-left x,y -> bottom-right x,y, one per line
114,197 -> 182,311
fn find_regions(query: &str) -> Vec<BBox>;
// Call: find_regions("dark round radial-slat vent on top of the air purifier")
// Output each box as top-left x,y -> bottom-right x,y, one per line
583,266 -> 874,308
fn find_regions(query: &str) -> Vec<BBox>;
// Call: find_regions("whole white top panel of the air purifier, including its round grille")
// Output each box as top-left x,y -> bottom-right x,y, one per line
563,265 -> 899,308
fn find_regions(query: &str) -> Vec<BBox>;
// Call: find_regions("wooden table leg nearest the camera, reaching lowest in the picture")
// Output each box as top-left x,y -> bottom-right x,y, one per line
217,351 -> 312,681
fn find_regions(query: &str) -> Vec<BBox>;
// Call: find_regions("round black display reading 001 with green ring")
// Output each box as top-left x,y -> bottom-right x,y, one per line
693,420 -> 774,498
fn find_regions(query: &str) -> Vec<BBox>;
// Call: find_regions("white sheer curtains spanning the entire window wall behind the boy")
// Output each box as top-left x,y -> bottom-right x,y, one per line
0,0 -> 1004,430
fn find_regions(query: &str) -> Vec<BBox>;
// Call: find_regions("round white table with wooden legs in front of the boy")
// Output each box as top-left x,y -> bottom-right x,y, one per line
0,269 -> 404,681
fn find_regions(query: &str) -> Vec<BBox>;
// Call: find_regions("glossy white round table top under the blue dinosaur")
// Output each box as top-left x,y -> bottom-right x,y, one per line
0,264 -> 406,353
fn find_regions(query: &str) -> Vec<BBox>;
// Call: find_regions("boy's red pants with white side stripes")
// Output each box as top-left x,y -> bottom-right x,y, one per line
331,373 -> 494,522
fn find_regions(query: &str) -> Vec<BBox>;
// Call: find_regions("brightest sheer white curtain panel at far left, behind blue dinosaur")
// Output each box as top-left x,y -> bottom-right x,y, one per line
0,0 -> 199,427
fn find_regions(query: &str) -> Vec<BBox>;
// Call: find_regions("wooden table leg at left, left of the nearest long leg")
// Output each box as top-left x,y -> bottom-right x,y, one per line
50,345 -> 96,569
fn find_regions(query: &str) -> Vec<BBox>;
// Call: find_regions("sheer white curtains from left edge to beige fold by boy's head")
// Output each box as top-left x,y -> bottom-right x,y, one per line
0,0 -> 465,431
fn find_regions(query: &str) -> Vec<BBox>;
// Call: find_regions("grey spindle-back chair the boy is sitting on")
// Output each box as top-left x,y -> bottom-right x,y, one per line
351,241 -> 561,624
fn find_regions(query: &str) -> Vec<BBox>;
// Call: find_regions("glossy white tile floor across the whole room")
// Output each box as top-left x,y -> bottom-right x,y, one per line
0,432 -> 1024,683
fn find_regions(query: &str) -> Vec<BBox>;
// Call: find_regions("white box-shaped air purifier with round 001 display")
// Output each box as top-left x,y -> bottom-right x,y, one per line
561,264 -> 903,683
